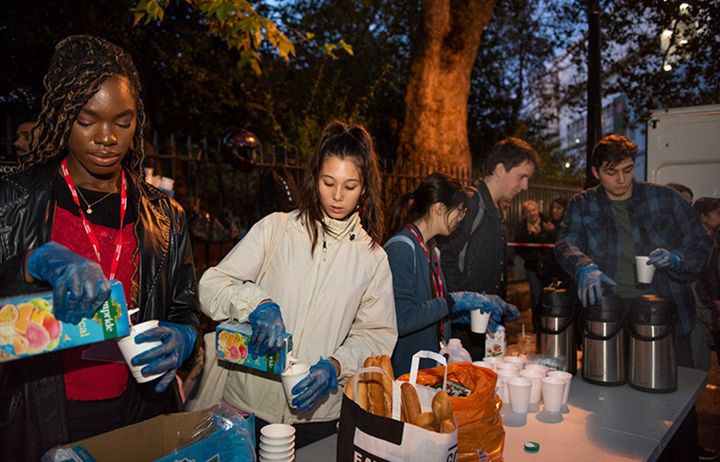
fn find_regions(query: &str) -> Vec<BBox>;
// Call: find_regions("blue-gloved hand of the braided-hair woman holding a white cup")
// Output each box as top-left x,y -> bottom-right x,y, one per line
130,321 -> 197,393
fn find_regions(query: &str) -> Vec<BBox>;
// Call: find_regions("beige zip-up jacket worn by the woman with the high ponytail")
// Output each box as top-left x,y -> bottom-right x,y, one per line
199,212 -> 397,423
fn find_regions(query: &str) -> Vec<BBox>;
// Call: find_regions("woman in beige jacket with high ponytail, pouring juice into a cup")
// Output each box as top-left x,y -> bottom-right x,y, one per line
200,121 -> 397,447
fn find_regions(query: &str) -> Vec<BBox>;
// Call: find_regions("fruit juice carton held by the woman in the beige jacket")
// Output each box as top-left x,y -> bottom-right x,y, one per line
215,320 -> 292,375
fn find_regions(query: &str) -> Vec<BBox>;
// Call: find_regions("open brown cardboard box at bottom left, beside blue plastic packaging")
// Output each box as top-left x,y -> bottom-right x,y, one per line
59,410 -> 209,462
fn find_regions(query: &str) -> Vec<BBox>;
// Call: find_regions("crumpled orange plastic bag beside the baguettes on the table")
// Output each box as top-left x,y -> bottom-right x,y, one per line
398,363 -> 505,462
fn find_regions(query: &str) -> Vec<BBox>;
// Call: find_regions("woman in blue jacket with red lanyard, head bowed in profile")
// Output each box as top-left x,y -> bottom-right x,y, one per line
385,173 -> 518,375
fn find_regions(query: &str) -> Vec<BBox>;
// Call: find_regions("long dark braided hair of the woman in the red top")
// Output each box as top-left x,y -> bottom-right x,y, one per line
19,35 -> 145,182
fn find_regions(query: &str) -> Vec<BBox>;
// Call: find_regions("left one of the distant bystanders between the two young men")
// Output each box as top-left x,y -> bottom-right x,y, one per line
515,200 -> 550,307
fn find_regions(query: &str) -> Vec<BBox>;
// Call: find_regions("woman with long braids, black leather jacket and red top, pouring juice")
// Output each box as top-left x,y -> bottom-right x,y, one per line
0,36 -> 199,460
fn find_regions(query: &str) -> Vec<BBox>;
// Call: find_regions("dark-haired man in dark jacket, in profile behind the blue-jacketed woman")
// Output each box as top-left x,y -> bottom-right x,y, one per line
438,137 -> 540,360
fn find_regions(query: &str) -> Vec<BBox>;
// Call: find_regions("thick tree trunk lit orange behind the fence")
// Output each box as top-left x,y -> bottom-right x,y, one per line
397,0 -> 494,170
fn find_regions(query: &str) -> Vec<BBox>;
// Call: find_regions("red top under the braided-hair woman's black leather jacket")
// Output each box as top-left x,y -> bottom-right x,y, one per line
50,207 -> 137,401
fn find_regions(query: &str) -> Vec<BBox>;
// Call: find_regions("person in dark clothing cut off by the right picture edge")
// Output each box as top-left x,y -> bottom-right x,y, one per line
692,197 -> 720,370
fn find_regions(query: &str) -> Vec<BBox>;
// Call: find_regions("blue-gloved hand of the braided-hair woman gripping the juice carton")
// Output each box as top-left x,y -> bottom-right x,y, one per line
27,241 -> 110,324
